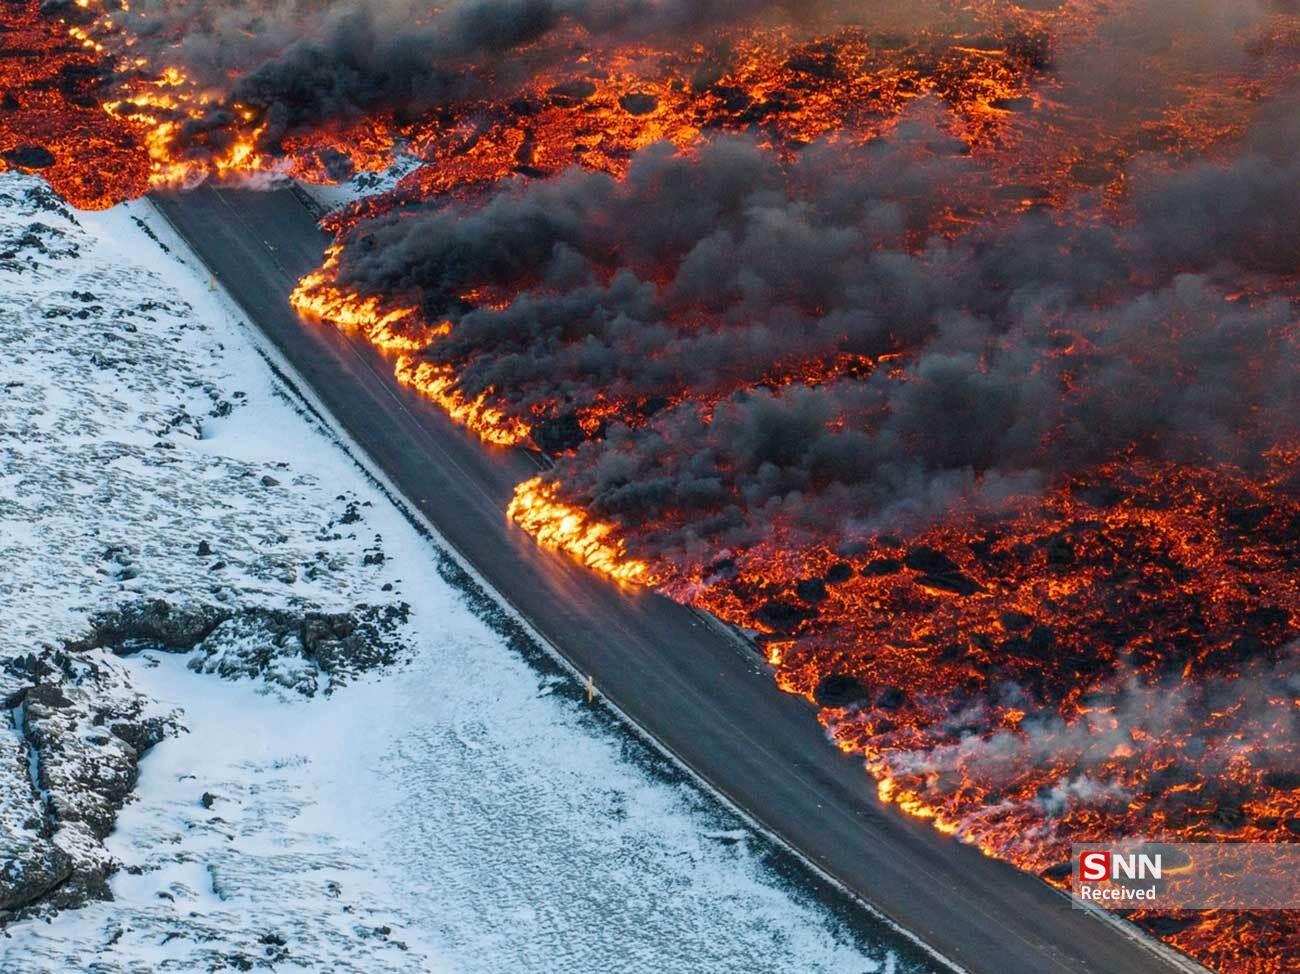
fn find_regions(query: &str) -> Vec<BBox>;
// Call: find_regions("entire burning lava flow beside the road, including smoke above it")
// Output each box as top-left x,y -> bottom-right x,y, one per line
0,0 -> 1300,974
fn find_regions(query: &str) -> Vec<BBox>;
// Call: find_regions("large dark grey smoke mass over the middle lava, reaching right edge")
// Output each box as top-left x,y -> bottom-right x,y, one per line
332,92 -> 1300,553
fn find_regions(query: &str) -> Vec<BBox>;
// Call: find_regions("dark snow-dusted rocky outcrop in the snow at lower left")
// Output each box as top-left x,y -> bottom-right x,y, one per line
0,599 -> 410,926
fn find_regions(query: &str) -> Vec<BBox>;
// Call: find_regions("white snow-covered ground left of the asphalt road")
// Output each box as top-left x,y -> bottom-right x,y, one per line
0,176 -> 935,974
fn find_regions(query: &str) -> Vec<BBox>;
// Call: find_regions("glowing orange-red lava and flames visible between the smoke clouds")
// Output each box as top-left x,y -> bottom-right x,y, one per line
0,0 -> 1300,974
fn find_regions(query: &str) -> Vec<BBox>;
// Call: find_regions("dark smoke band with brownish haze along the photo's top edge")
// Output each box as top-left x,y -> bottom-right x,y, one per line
105,0 -> 1097,156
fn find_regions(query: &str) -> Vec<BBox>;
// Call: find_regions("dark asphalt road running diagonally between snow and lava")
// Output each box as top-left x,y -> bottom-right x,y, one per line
156,189 -> 1196,974
